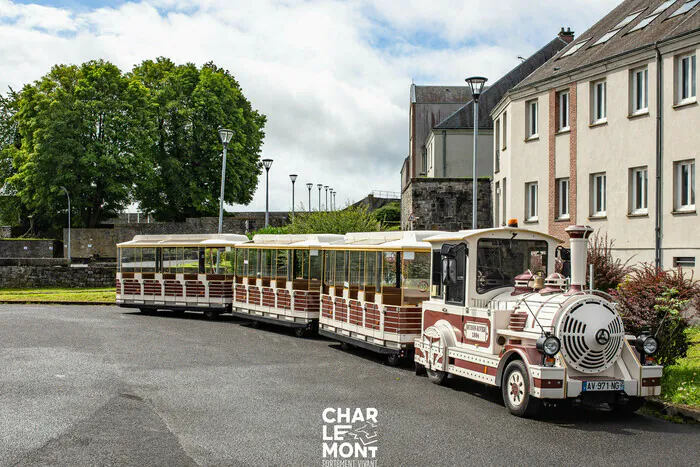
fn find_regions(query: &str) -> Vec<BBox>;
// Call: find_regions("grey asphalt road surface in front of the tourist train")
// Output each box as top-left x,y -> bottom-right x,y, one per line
0,305 -> 700,466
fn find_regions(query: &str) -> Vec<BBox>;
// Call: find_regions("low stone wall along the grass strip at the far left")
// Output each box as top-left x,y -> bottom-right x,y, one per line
0,266 -> 116,289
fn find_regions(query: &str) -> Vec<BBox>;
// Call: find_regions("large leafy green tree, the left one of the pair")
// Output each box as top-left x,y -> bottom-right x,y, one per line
8,60 -> 152,227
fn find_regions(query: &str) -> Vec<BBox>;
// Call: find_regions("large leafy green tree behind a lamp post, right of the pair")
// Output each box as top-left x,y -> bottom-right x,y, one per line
132,58 -> 266,221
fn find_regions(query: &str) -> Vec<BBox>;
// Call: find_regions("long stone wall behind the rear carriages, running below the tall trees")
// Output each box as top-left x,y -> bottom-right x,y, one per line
63,212 -> 289,259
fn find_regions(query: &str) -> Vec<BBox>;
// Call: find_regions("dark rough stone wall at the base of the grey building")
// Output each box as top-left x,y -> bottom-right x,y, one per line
401,178 -> 493,231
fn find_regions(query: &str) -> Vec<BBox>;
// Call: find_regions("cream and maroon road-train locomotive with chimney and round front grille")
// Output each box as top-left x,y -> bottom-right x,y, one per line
415,224 -> 662,416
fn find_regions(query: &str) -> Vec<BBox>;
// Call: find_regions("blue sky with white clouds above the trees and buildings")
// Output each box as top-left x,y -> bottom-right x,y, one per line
0,0 -> 620,211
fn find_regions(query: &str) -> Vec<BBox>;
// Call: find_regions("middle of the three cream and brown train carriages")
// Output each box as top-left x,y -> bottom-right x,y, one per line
232,235 -> 343,337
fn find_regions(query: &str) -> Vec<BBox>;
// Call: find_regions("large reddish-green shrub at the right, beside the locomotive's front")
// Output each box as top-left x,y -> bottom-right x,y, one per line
611,263 -> 700,365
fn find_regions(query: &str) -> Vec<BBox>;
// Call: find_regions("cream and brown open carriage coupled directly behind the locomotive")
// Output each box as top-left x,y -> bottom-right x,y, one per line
319,232 -> 438,364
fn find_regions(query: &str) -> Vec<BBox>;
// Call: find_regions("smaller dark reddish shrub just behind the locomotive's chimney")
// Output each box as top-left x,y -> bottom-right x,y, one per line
586,233 -> 630,292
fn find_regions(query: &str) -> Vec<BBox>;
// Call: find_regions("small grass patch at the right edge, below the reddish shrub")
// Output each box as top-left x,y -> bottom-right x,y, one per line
661,327 -> 700,409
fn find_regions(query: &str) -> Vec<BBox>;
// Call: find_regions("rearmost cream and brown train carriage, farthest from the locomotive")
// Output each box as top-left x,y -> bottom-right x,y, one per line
116,234 -> 248,317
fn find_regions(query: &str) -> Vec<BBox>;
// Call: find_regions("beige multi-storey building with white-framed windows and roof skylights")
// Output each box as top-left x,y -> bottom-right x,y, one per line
491,0 -> 700,268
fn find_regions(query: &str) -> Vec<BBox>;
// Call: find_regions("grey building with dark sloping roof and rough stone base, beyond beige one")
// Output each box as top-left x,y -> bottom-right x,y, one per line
401,29 -> 573,229
